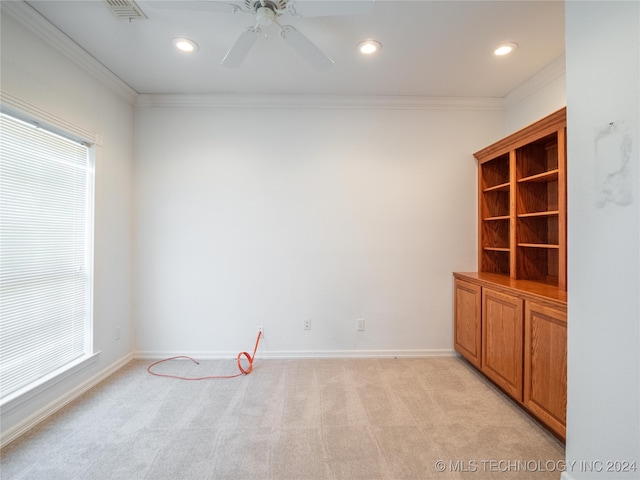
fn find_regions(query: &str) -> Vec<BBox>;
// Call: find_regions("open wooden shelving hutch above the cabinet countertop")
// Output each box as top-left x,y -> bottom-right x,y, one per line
475,109 -> 567,289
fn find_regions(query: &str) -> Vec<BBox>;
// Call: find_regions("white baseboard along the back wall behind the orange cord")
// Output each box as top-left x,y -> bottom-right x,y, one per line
133,349 -> 456,360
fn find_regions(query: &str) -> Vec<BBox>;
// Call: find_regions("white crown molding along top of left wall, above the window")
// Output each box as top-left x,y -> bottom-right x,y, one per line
0,0 -> 138,105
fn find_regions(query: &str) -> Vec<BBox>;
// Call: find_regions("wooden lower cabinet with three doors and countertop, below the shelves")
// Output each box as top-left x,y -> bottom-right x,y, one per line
453,272 -> 567,440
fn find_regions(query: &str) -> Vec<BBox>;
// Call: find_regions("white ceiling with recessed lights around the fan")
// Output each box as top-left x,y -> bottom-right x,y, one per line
22,0 -> 564,98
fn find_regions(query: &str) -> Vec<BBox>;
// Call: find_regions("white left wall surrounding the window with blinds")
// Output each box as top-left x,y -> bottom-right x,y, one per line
1,6 -> 133,437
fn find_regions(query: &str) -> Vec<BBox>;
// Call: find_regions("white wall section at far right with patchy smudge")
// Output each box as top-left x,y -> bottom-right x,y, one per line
565,1 -> 640,480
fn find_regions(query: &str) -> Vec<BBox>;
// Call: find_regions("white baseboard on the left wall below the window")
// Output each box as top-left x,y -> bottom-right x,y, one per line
0,353 -> 134,448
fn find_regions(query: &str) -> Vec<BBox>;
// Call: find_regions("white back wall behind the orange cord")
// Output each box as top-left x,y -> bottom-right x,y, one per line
134,102 -> 502,356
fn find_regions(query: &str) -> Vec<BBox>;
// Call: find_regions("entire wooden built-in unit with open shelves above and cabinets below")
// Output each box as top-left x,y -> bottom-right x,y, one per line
454,108 -> 567,440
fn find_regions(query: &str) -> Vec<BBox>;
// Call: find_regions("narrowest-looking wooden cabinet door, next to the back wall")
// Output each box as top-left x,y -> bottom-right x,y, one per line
454,279 -> 482,368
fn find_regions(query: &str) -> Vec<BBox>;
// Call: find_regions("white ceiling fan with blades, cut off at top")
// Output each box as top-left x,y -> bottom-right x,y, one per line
146,0 -> 374,71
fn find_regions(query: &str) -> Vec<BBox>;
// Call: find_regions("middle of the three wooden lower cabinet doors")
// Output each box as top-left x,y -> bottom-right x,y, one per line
482,288 -> 524,402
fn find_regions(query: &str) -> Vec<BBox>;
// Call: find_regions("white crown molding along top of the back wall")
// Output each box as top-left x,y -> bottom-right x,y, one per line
136,94 -> 504,110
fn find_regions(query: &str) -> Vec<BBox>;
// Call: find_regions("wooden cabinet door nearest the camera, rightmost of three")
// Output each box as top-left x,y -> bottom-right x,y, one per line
524,302 -> 567,438
